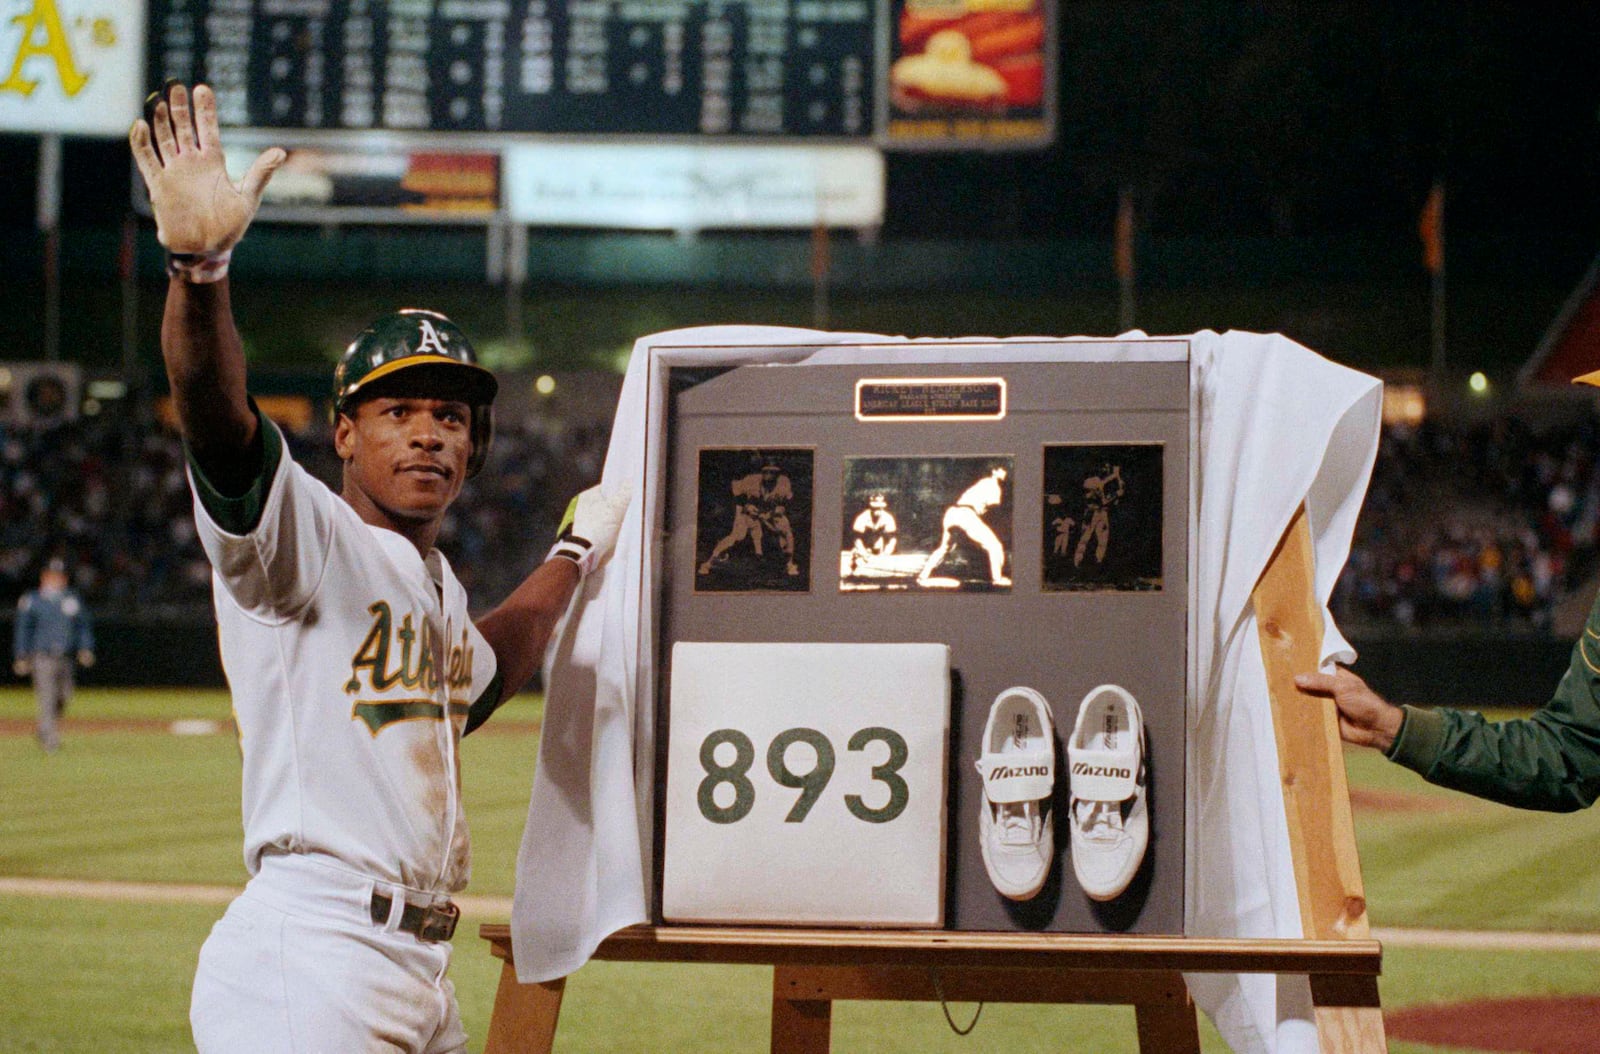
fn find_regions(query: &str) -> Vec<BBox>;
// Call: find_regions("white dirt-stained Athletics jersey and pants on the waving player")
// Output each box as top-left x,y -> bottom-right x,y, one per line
190,419 -> 499,1051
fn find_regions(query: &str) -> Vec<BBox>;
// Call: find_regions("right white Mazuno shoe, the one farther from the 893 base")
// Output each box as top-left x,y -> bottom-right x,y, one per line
1067,685 -> 1150,900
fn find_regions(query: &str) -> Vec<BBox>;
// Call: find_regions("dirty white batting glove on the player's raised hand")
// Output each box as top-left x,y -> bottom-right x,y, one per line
128,82 -> 288,281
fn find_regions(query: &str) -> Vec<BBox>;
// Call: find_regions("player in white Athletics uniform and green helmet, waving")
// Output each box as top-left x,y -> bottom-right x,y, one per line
130,85 -> 626,1054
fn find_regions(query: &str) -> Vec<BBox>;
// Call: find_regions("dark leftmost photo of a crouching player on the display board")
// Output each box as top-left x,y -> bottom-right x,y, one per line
694,446 -> 813,593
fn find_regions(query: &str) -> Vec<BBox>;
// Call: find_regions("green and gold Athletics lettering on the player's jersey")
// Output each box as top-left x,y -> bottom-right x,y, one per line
344,598 -> 472,736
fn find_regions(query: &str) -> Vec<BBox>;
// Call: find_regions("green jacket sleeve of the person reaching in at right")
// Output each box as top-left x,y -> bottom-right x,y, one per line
1389,601 -> 1600,812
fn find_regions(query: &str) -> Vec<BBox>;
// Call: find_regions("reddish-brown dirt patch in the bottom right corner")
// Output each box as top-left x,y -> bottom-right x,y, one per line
1384,995 -> 1600,1054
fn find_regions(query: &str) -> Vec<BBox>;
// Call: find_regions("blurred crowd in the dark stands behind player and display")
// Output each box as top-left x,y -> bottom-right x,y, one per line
0,401 -> 1600,633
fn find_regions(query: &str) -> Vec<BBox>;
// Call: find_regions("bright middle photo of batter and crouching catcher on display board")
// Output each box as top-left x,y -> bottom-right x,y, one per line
838,456 -> 1011,592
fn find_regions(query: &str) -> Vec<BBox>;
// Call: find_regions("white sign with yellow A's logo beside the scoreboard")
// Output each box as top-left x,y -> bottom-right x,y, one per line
0,0 -> 144,136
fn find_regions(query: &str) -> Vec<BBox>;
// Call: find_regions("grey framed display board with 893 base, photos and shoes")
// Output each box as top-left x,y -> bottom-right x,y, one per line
646,348 -> 1194,934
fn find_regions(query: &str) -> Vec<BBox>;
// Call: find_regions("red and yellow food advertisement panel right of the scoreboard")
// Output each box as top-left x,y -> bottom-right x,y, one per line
888,0 -> 1054,149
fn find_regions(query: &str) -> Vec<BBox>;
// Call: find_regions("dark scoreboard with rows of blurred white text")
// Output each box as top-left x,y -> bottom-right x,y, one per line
149,0 -> 877,136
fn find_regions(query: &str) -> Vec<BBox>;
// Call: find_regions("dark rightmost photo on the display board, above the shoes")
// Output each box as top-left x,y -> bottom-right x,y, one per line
1043,443 -> 1163,592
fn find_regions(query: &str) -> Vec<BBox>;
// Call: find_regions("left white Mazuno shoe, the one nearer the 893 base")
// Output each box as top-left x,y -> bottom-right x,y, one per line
978,688 -> 1056,900
